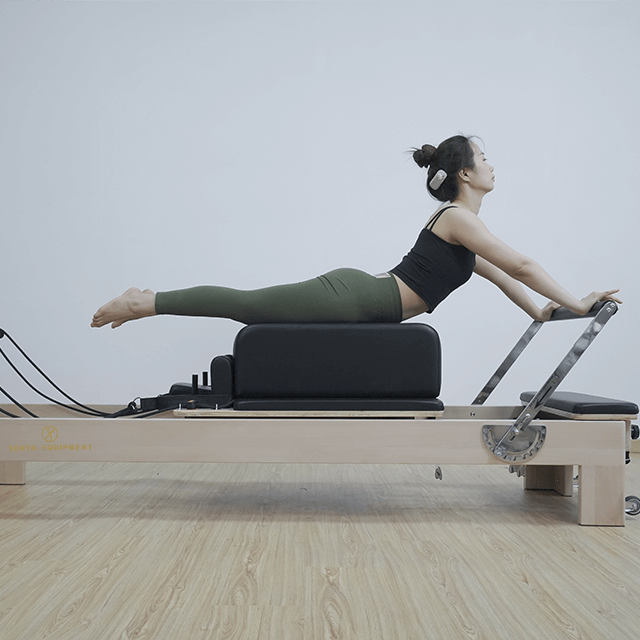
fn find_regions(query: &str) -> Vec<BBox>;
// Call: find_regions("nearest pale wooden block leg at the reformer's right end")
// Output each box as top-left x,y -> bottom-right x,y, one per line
579,466 -> 624,527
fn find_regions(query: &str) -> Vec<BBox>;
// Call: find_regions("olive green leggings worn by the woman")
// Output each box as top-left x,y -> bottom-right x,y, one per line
156,269 -> 402,324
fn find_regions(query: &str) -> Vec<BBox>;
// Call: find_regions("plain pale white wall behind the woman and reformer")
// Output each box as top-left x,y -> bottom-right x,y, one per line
0,1 -> 640,404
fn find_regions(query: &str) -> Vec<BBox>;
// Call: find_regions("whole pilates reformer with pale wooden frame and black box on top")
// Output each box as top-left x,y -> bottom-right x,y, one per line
0,302 -> 640,526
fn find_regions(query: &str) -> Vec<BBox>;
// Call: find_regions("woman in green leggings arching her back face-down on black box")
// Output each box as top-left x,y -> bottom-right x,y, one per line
91,136 -> 620,329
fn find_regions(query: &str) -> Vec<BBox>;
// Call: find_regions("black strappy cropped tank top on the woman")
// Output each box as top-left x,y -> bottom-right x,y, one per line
390,205 -> 476,313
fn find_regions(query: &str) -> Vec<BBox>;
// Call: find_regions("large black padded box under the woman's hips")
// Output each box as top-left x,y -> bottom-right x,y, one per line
233,324 -> 443,411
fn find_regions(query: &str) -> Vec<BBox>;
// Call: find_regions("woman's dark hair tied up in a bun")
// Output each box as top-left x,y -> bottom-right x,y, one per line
413,135 -> 475,202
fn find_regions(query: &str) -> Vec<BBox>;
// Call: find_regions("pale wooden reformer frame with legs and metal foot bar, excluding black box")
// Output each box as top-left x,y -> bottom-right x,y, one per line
0,302 -> 637,526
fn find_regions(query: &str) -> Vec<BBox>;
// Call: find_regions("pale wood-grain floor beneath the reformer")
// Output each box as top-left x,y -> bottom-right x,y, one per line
0,454 -> 640,640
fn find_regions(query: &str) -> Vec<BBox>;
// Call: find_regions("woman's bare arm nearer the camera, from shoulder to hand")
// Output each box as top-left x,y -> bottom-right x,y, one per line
447,209 -> 620,315
